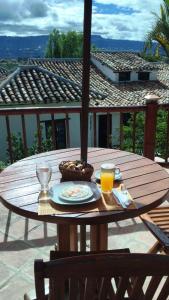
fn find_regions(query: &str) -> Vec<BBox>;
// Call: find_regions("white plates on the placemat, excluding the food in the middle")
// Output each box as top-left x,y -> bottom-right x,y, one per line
49,181 -> 101,205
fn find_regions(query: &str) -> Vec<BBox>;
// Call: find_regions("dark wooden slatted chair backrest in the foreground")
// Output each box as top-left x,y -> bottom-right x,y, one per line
35,253 -> 169,300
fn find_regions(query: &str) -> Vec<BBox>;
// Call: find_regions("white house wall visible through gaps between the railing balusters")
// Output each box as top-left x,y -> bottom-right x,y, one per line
0,113 -> 120,161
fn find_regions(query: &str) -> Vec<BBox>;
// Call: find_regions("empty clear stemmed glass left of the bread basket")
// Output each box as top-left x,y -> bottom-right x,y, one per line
36,161 -> 52,192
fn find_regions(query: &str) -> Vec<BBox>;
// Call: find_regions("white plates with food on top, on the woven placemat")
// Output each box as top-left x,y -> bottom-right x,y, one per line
50,181 -> 101,205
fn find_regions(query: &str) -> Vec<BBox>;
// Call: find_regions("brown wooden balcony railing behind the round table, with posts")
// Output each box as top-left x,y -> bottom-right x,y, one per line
0,101 -> 169,164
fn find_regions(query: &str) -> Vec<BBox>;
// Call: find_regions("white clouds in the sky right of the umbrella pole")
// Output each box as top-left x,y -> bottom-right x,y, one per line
92,0 -> 161,40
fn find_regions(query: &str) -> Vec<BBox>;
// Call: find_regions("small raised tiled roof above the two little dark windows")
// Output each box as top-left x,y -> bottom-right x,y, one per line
91,52 -> 159,72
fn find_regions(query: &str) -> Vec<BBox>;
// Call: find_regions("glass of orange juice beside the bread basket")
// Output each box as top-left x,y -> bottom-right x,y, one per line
100,163 -> 115,193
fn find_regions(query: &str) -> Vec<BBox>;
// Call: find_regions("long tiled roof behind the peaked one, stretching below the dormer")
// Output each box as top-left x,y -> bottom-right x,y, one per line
30,59 -> 169,107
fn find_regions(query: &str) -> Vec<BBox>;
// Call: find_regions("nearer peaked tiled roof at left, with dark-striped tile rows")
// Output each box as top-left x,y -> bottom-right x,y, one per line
0,65 -> 105,105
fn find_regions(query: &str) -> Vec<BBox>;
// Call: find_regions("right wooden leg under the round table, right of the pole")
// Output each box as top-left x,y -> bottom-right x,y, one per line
90,224 -> 108,251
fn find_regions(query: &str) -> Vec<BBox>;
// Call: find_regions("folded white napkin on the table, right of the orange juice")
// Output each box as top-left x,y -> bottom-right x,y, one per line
112,188 -> 132,208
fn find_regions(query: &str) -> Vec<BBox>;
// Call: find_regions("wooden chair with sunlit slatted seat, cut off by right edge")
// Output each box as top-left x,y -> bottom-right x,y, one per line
141,201 -> 169,254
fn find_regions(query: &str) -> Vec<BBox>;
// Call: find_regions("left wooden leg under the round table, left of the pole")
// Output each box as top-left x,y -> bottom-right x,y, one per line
57,224 -> 78,251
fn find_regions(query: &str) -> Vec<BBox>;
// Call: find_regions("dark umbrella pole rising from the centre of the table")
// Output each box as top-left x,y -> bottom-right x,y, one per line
81,0 -> 92,162
